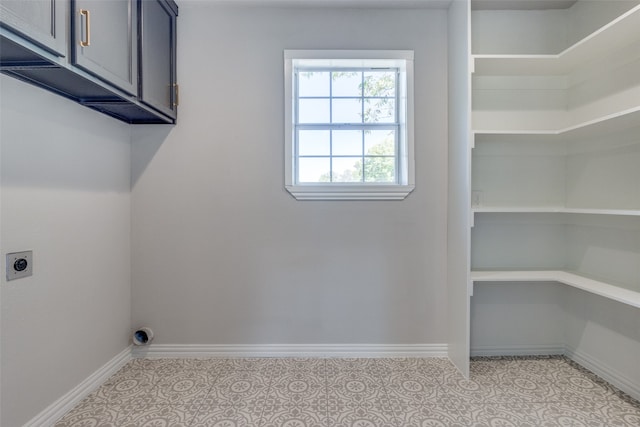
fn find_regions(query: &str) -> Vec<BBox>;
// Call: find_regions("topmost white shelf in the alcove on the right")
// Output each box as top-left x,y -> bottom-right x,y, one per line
472,5 -> 640,76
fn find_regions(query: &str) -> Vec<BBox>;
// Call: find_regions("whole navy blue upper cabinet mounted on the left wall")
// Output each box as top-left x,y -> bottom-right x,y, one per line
0,0 -> 178,123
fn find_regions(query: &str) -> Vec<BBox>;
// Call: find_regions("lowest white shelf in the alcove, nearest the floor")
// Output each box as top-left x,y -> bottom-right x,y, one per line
471,270 -> 640,308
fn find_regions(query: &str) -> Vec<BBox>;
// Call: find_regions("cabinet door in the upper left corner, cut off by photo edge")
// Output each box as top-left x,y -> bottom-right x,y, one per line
0,0 -> 69,56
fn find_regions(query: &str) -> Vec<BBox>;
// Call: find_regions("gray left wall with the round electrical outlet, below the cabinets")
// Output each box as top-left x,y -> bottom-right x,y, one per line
0,76 -> 131,427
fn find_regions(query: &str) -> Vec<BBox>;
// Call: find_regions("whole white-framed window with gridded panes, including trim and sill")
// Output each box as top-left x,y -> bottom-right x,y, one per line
285,50 -> 414,200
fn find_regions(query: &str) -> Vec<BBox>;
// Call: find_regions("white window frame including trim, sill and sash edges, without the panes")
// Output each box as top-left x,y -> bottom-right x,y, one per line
284,50 -> 415,200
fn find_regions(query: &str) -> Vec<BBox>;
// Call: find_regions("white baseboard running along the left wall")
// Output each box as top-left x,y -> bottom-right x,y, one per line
23,346 -> 131,427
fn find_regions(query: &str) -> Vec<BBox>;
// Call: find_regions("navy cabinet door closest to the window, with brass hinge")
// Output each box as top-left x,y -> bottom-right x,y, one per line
139,0 -> 178,118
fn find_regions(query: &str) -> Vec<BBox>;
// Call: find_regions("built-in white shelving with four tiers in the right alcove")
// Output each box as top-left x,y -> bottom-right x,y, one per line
471,0 -> 640,344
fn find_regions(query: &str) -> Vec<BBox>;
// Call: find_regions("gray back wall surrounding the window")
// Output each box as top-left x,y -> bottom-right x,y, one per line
132,1 -> 447,344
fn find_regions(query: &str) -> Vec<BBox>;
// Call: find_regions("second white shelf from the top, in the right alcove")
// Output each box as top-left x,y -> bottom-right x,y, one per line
473,106 -> 640,142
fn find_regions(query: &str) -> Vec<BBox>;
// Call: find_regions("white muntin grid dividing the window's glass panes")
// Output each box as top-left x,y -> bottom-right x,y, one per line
293,67 -> 401,185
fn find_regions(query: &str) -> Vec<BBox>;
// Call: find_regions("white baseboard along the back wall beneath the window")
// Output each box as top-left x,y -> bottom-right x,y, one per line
133,344 -> 447,358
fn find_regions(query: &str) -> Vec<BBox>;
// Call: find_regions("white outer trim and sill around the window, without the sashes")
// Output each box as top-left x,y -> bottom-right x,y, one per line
284,50 -> 415,200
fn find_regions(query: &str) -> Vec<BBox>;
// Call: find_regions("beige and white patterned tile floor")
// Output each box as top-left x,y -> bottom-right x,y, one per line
56,357 -> 640,427
